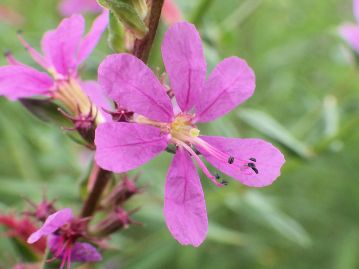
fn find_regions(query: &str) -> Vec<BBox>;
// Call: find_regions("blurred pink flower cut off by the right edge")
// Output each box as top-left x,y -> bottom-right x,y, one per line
339,0 -> 359,53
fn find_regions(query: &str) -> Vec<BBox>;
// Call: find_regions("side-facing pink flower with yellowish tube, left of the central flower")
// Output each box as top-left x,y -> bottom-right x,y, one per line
0,12 -> 108,119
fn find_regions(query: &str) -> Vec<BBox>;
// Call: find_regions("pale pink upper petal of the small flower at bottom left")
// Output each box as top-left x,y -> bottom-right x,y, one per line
27,208 -> 73,244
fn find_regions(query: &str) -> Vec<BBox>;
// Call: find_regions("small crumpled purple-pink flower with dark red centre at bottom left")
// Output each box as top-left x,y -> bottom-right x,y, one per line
27,208 -> 102,269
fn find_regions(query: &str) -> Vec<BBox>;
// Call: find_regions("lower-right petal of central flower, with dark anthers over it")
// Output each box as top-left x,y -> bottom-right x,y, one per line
199,136 -> 285,187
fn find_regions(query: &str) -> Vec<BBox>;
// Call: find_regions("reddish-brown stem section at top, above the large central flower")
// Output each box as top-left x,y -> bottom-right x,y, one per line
133,0 -> 164,63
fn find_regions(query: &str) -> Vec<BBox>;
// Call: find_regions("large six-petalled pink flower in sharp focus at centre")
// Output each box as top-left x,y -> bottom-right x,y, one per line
95,22 -> 285,246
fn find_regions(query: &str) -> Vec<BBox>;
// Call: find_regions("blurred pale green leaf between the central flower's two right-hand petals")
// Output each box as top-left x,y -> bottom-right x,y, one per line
237,109 -> 313,158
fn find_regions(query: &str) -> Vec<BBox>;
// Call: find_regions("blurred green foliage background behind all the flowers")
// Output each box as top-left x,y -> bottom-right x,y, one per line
0,0 -> 359,269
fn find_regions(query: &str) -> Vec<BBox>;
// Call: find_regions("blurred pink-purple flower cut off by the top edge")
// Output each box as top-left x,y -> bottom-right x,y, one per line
59,0 -> 102,16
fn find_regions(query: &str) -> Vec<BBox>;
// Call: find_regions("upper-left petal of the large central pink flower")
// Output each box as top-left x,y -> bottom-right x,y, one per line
98,54 -> 173,122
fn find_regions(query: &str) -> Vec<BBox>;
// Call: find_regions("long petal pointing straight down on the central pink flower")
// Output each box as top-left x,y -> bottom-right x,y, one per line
164,149 -> 208,247
